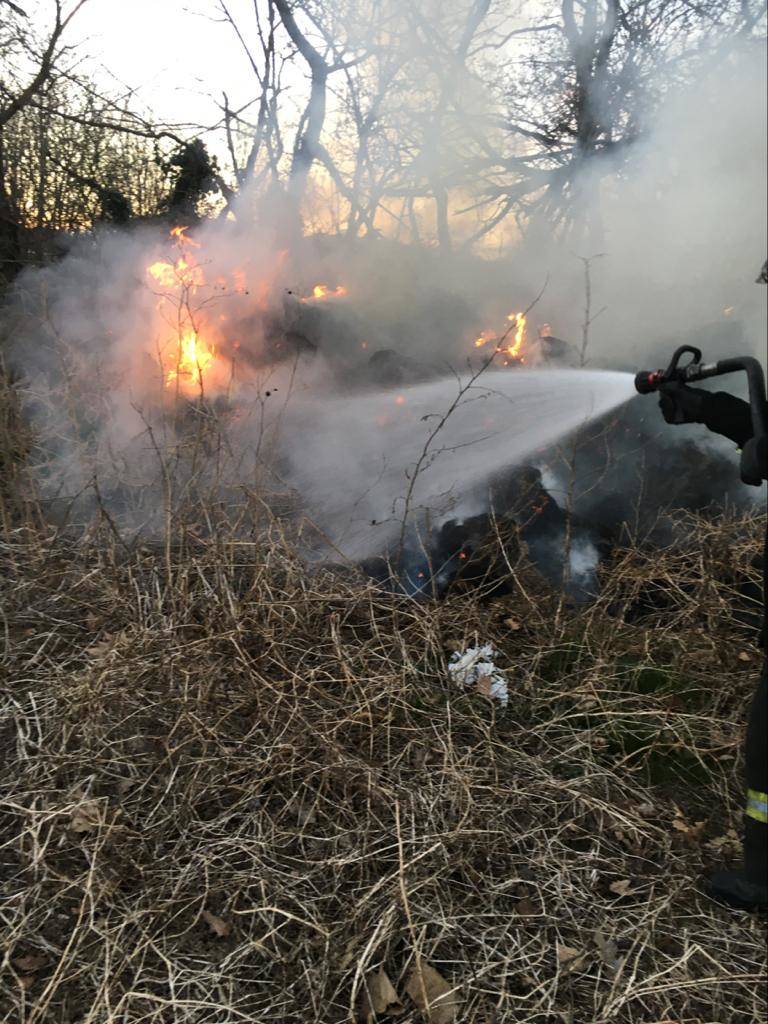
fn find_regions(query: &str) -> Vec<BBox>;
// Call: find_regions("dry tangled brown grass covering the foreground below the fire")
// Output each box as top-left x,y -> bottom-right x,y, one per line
0,497 -> 766,1024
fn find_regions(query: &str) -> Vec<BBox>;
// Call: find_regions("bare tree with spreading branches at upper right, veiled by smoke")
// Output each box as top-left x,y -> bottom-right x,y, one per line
470,0 -> 766,248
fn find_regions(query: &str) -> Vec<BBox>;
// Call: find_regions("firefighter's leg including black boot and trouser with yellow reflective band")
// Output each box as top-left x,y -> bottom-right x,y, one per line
711,668 -> 768,908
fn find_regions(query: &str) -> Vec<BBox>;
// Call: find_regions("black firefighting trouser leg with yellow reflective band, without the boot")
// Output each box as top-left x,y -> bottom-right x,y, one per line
744,664 -> 768,886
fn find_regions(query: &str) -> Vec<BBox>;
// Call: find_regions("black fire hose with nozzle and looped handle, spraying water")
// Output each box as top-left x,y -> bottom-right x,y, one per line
635,345 -> 768,487
